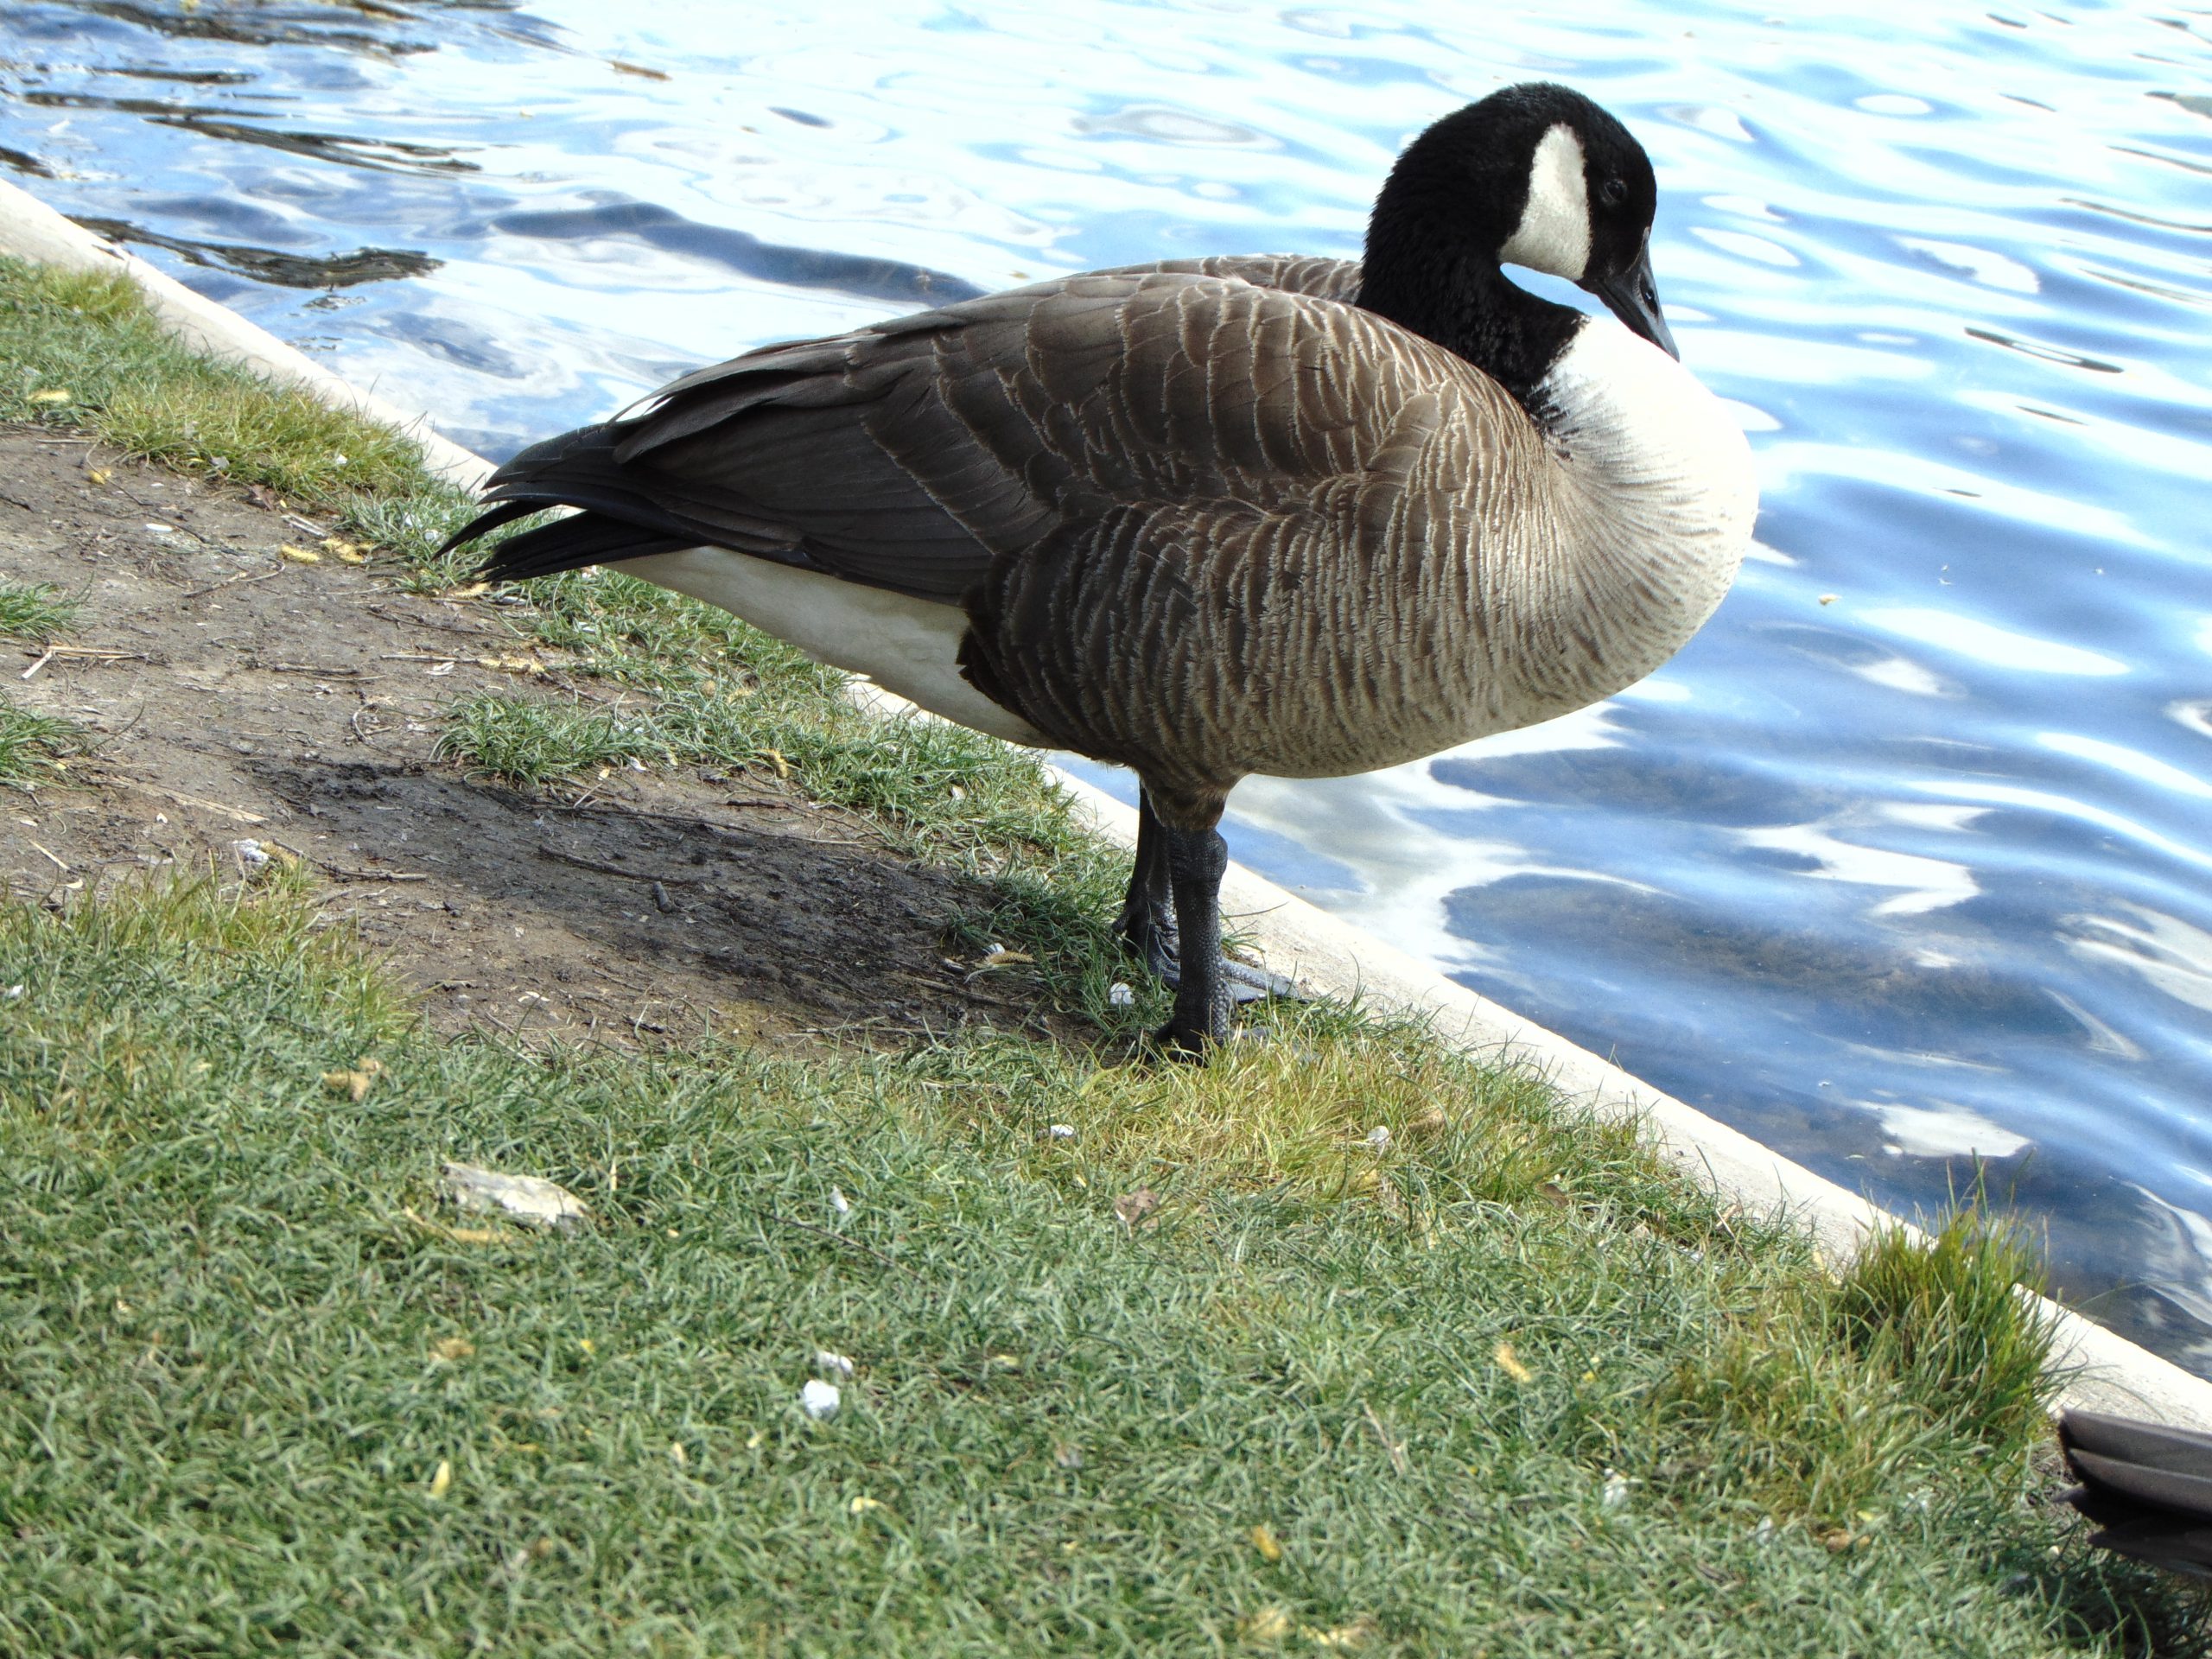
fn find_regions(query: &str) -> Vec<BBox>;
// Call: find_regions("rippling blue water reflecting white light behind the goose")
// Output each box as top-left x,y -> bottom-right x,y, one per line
13,0 -> 2212,1376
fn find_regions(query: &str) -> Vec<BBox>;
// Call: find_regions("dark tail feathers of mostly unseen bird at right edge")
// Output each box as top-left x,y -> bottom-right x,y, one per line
2059,1411 -> 2212,1577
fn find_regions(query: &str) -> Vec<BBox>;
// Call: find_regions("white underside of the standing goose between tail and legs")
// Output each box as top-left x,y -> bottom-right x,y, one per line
621,546 -> 1046,746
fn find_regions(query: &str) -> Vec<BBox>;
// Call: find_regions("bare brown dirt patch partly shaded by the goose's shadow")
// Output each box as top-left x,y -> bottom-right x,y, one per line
0,429 -> 1061,1042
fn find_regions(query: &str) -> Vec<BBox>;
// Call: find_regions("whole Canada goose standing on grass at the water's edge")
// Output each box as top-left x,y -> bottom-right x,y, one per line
454,84 -> 1757,1053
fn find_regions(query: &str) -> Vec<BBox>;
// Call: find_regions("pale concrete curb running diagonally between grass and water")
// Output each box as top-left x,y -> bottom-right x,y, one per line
0,181 -> 2212,1431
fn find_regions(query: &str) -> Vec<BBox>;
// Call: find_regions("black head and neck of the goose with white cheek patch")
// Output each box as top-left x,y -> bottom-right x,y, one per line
1360,82 -> 1676,416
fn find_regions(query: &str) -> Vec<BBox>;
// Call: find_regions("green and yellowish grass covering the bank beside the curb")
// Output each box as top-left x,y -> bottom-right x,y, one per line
0,264 -> 2201,1659
